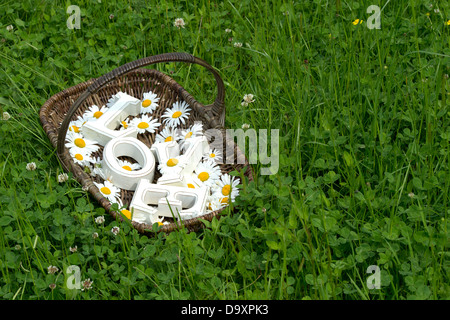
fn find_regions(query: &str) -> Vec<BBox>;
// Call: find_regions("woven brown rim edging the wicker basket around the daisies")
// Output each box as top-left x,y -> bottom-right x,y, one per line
39,68 -> 253,236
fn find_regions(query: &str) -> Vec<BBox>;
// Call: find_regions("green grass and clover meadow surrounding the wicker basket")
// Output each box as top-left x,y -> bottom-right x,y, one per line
0,0 -> 450,300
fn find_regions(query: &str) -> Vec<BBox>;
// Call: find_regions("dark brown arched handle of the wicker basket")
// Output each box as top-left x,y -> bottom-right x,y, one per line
57,52 -> 225,164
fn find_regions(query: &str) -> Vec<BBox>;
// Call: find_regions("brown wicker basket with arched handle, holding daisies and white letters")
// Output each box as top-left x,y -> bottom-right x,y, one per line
40,53 -> 253,235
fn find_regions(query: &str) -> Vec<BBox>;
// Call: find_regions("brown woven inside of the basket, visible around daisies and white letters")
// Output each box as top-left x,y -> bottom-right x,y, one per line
41,69 -> 252,231
